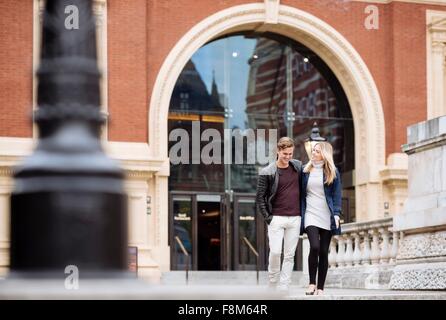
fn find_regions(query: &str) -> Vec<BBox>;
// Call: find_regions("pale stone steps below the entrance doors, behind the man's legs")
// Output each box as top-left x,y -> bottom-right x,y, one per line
161,271 -> 304,285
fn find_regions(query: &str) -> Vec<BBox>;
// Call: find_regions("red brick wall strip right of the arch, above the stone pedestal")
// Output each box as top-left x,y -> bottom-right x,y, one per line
387,2 -> 428,154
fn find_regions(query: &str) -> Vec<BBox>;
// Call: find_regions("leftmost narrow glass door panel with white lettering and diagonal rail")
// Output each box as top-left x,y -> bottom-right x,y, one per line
173,197 -> 193,270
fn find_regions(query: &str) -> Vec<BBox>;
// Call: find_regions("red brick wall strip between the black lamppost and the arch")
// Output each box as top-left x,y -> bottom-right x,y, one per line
107,0 -> 149,142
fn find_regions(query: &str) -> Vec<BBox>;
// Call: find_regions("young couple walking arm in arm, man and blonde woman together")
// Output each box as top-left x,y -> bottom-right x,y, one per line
256,137 -> 342,295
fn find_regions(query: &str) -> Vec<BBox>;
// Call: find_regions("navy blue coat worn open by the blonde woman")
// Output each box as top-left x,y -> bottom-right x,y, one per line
300,166 -> 342,235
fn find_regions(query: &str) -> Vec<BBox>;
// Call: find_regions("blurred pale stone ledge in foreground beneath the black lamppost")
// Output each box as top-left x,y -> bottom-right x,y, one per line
0,279 -> 288,300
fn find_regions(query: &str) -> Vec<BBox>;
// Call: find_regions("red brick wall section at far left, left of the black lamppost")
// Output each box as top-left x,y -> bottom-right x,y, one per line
0,1 -> 33,137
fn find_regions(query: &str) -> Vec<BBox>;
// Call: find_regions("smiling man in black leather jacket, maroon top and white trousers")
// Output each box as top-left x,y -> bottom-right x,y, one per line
256,137 -> 302,290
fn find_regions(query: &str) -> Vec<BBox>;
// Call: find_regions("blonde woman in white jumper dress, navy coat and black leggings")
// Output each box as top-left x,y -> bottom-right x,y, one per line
301,141 -> 342,295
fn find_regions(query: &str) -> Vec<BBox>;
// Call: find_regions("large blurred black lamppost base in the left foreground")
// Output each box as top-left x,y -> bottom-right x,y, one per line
10,0 -> 127,277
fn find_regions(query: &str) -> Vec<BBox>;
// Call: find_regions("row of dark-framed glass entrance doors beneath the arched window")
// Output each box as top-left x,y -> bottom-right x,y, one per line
169,192 -> 302,270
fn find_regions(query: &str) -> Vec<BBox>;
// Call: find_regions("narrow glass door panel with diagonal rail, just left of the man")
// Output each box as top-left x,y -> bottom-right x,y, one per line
238,199 -> 258,270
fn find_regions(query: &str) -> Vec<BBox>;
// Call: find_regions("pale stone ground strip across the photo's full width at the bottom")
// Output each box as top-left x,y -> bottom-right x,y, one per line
0,279 -> 446,300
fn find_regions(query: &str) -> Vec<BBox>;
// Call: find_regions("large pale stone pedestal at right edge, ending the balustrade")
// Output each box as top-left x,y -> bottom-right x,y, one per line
390,116 -> 446,290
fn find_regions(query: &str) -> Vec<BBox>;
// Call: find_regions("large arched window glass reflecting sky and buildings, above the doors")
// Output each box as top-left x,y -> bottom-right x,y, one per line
169,33 -> 354,220
